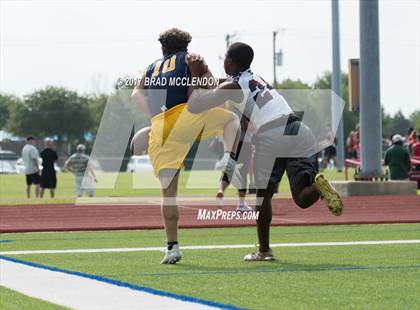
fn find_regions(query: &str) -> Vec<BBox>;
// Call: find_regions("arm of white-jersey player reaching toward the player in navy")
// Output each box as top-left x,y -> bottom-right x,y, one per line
187,81 -> 243,113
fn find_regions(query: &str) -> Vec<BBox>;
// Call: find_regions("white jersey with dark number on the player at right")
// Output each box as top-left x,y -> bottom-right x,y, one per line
231,69 -> 293,130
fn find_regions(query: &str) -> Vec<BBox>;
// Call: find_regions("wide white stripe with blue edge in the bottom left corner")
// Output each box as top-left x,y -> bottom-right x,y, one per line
0,259 -> 212,310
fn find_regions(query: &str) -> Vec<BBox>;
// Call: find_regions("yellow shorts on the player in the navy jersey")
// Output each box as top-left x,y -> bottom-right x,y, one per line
148,104 -> 232,176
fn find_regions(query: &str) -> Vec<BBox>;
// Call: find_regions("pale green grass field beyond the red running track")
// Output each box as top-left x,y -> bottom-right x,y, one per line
0,170 -> 352,205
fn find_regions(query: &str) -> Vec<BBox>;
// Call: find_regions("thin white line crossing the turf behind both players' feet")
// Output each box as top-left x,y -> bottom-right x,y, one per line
0,239 -> 420,255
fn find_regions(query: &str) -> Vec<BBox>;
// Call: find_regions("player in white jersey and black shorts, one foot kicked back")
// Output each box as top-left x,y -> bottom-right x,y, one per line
188,42 -> 343,261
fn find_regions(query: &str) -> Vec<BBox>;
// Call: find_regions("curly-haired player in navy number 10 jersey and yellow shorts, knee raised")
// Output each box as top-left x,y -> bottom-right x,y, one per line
132,28 -> 241,264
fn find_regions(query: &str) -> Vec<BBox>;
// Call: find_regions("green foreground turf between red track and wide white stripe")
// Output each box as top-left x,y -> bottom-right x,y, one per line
0,224 -> 420,309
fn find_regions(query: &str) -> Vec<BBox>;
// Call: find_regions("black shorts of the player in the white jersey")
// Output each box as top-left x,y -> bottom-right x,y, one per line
252,116 -> 318,190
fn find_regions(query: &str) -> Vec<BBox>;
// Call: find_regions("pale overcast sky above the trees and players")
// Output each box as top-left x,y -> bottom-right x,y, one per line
0,0 -> 420,115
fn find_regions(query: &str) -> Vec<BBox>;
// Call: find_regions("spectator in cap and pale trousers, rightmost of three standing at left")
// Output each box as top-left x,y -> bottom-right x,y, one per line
64,144 -> 96,197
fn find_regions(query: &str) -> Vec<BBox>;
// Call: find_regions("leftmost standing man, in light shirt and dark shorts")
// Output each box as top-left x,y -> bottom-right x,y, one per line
22,136 -> 40,198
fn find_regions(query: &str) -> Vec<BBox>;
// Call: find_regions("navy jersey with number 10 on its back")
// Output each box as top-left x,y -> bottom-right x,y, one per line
145,52 -> 191,117
